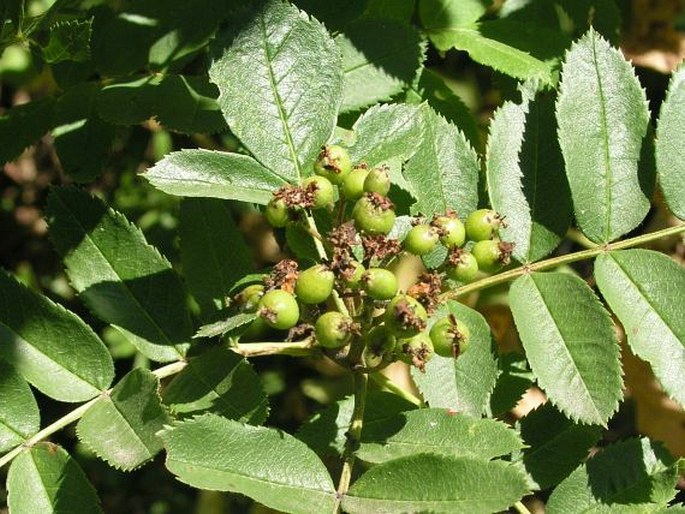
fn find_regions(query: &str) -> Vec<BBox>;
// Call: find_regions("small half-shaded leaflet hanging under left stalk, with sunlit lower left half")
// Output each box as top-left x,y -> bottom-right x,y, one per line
76,368 -> 171,471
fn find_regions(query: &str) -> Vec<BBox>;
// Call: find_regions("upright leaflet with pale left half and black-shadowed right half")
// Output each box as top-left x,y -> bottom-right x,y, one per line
487,87 -> 571,262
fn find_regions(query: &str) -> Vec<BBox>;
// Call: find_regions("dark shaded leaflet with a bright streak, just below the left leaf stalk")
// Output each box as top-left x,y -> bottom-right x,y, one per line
163,348 -> 269,425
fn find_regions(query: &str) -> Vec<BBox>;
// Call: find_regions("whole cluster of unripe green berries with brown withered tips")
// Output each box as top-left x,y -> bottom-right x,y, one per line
236,145 -> 511,370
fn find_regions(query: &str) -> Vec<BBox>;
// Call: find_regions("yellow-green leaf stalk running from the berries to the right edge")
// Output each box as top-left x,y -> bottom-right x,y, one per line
440,223 -> 685,301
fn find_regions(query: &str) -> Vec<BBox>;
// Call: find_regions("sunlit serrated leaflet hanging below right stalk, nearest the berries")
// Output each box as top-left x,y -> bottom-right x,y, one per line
509,273 -> 623,426
